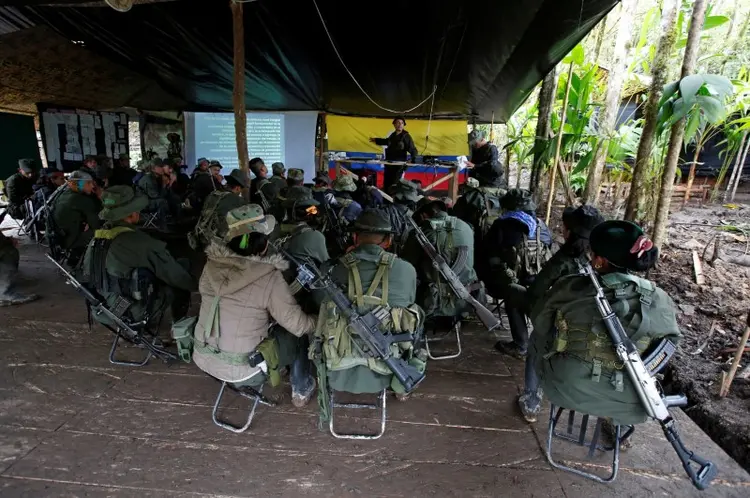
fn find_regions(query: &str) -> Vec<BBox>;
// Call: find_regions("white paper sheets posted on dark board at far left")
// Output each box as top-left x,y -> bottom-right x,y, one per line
37,104 -> 129,172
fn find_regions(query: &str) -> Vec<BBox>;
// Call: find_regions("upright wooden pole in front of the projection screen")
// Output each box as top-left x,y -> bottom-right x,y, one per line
229,0 -> 250,197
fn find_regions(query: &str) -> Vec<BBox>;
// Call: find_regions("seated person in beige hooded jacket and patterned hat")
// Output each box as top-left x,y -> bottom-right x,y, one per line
193,204 -> 315,406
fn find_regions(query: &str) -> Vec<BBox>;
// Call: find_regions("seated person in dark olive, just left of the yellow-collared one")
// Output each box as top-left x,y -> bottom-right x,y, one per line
51,170 -> 102,266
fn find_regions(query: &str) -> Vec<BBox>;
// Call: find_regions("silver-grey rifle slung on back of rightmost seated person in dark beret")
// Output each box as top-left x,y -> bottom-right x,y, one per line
578,262 -> 717,489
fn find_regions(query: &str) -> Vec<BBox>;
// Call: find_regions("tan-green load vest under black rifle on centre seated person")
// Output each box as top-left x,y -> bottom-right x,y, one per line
310,252 -> 426,392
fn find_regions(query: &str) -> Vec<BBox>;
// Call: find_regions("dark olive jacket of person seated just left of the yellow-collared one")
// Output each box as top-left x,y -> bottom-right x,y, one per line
52,188 -> 102,249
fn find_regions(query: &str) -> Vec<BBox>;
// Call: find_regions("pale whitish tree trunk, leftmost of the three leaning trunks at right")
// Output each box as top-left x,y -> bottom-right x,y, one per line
583,0 -> 638,205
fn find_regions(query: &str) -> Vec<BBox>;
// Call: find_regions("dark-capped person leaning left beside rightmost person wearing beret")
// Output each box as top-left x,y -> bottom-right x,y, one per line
518,205 -> 604,422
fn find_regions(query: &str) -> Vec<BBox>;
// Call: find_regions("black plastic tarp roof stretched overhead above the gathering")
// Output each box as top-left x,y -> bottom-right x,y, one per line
0,0 -> 617,122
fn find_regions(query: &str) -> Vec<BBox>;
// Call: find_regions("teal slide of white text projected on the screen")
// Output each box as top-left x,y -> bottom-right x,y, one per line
194,112 -> 285,171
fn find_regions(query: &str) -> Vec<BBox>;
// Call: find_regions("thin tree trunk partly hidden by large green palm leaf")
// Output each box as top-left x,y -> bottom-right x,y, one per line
651,0 -> 708,248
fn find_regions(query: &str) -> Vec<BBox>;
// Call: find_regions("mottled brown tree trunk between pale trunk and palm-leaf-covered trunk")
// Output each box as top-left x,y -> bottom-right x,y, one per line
625,0 -> 679,221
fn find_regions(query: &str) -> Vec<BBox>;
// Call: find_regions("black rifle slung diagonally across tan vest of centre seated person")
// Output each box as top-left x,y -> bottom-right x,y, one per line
277,246 -> 425,393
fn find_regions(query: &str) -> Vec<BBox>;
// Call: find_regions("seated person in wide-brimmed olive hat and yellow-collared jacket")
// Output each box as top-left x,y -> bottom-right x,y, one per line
84,185 -> 196,325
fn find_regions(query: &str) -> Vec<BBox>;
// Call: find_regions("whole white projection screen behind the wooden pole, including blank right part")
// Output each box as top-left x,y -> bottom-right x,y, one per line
185,111 -> 318,182
